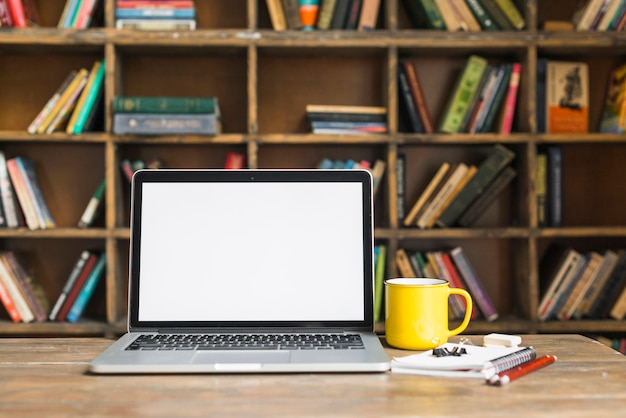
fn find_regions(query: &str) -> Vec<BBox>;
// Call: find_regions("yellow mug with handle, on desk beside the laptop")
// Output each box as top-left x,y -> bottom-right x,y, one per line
385,278 -> 472,350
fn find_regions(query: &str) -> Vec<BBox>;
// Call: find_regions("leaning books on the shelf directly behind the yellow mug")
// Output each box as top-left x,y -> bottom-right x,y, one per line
394,246 -> 499,321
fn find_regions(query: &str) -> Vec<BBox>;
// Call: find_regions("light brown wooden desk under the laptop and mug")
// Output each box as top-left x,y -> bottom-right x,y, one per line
0,335 -> 626,417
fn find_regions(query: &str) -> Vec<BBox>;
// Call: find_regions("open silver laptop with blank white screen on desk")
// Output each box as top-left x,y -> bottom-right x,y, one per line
89,169 -> 390,373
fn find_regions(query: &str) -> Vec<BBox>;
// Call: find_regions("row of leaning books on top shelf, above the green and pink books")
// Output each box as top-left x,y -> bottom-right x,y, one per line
403,0 -> 526,32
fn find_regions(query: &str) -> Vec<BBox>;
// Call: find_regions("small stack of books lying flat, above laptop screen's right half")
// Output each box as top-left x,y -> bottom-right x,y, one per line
306,104 -> 387,135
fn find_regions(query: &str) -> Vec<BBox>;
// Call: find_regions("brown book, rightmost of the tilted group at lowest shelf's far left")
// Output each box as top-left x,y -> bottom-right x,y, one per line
0,251 -> 50,322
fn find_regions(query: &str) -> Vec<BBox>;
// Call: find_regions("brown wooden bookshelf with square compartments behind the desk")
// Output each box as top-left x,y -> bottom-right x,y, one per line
0,0 -> 626,336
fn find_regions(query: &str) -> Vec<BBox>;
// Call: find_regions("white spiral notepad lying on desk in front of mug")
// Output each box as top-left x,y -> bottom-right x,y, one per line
391,343 -> 536,379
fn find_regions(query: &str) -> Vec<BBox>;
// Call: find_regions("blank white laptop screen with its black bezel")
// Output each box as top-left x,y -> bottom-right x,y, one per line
130,170 -> 372,327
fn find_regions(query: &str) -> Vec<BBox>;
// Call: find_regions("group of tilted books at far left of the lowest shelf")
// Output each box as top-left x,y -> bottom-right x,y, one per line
0,251 -> 50,322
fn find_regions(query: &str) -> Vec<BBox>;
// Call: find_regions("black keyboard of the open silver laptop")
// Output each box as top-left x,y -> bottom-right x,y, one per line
126,334 -> 364,350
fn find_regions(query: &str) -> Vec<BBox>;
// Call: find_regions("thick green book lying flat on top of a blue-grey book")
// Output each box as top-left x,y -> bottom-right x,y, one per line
113,96 -> 219,113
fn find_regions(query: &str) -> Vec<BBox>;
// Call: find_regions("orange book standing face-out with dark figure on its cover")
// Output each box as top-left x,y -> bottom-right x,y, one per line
545,60 -> 589,133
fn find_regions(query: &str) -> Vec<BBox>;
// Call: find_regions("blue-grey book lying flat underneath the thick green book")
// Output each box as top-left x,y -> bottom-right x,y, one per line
113,113 -> 222,135
